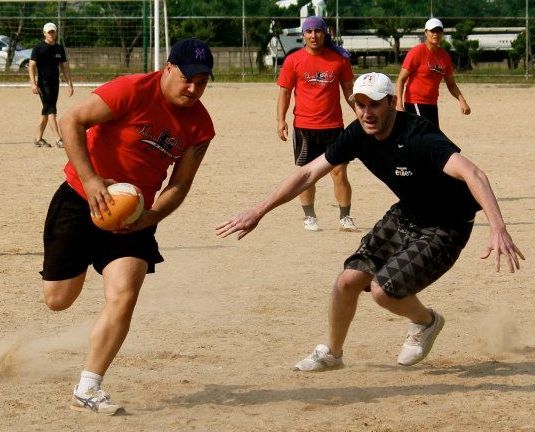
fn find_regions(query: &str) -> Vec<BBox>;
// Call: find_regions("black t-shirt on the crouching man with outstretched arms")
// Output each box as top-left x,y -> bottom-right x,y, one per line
325,112 -> 481,225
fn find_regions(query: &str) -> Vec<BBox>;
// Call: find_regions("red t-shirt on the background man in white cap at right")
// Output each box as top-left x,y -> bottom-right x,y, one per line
402,43 -> 453,105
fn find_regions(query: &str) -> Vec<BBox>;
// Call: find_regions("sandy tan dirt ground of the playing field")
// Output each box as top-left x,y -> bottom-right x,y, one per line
0,82 -> 535,432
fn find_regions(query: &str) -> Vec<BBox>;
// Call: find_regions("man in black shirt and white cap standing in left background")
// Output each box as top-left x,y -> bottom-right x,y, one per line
29,23 -> 74,147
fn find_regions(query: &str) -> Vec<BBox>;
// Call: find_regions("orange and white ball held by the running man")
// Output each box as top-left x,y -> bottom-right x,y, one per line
91,183 -> 145,231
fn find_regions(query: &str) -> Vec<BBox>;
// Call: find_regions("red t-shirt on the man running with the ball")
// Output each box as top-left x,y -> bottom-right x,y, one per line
64,71 -> 215,209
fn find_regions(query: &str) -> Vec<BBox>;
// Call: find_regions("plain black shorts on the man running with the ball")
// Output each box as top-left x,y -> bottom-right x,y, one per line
41,183 -> 163,281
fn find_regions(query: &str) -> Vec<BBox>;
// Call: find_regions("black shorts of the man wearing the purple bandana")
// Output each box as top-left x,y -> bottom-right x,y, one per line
294,127 -> 344,166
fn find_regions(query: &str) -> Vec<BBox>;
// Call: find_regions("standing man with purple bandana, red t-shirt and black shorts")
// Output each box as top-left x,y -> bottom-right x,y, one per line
277,16 -> 357,232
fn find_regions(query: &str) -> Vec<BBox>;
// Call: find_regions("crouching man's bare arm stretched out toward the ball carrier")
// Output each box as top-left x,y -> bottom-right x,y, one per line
216,155 -> 334,240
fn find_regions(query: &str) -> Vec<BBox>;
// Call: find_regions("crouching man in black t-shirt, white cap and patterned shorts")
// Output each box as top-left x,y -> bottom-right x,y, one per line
217,73 -> 524,371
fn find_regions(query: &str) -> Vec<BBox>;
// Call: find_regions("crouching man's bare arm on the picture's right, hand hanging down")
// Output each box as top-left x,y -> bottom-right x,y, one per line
444,153 -> 524,273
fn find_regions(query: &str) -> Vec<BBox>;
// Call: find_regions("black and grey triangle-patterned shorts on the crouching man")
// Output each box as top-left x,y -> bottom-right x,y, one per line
344,205 -> 474,298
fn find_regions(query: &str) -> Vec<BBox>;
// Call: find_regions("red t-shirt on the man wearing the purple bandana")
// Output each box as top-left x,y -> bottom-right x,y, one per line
277,48 -> 353,129
